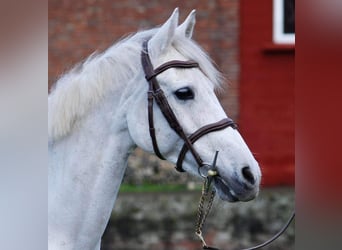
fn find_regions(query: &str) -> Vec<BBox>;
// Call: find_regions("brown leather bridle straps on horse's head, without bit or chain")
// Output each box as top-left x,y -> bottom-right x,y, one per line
141,41 -> 236,172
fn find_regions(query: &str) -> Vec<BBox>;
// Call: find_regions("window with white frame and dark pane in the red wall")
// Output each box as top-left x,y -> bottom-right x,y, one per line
273,0 -> 295,44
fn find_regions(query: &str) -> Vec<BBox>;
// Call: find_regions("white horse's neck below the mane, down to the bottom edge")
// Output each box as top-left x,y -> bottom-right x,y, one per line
49,82 -> 134,249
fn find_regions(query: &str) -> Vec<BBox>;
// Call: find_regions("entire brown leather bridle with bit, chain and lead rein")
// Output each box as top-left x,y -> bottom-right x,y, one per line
141,40 -> 295,250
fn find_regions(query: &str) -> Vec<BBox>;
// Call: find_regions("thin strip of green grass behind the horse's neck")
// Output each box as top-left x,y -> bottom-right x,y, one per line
120,183 -> 198,193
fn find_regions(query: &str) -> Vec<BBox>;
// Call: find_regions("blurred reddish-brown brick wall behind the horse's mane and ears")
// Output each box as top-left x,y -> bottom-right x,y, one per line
49,0 -> 239,119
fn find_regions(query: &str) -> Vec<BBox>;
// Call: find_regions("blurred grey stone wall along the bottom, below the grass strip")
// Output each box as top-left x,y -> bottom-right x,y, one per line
101,188 -> 295,250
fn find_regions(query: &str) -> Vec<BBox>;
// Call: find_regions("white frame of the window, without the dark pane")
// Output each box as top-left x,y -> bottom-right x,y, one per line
273,0 -> 295,44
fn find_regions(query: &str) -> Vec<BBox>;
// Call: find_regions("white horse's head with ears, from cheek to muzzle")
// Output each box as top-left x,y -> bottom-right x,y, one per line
127,9 -> 261,202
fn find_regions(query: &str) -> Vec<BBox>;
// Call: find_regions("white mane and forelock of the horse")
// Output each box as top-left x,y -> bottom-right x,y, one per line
48,29 -> 222,141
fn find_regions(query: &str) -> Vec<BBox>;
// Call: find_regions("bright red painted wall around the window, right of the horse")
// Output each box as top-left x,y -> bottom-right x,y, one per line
239,0 -> 295,186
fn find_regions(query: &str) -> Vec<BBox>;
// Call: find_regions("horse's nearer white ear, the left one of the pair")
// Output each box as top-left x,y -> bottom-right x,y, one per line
149,8 -> 179,56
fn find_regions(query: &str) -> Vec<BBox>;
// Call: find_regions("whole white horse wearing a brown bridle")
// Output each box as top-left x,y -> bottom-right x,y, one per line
48,9 -> 261,250
